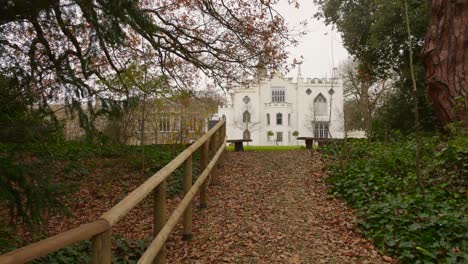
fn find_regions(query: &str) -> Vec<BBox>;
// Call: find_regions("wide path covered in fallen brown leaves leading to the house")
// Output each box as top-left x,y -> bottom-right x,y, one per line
167,150 -> 392,263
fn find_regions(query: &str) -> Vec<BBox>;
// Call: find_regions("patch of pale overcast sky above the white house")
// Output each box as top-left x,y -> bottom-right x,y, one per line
277,0 -> 348,78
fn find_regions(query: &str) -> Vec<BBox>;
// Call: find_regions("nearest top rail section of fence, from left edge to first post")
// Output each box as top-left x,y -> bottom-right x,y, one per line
0,219 -> 110,264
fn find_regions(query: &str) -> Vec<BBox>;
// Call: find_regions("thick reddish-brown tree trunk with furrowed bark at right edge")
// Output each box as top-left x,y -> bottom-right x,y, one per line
423,0 -> 468,125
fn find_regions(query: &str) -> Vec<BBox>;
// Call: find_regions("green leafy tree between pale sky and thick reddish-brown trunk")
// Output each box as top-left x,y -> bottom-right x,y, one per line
314,0 -> 434,136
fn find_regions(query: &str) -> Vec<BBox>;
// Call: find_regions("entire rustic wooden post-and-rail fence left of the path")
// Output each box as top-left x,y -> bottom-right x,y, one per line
0,120 -> 226,264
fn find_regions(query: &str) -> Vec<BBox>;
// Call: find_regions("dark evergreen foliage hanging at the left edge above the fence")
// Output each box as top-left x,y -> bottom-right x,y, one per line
0,76 -> 69,226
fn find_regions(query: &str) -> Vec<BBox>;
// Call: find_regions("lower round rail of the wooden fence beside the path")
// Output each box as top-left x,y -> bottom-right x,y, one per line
138,143 -> 226,264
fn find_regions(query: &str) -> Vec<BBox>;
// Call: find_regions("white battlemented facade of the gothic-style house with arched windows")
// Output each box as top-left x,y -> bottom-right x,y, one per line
218,75 -> 344,145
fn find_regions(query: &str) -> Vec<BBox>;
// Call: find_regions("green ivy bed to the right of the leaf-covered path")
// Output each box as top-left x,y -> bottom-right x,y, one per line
328,135 -> 468,263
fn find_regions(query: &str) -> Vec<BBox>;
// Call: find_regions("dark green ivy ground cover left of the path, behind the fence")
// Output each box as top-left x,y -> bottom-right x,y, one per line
0,142 -> 200,256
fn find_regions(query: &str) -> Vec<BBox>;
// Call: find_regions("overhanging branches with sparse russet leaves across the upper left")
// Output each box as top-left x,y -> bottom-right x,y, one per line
0,0 -> 294,106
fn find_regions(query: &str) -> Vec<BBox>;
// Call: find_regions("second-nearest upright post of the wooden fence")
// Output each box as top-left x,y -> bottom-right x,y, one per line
153,180 -> 167,264
